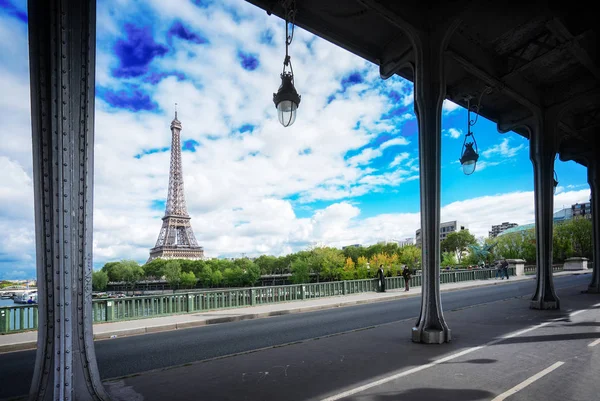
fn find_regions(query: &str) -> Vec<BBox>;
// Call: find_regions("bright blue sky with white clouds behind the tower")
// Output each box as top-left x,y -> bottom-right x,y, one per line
0,0 -> 589,279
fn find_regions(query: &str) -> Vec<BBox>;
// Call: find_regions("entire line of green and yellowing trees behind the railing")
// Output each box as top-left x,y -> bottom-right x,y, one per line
92,219 -> 592,291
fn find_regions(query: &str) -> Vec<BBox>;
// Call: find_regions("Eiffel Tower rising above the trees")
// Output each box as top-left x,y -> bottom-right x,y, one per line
148,110 -> 204,262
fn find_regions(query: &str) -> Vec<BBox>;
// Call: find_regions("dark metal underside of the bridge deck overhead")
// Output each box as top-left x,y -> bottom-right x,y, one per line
247,0 -> 600,166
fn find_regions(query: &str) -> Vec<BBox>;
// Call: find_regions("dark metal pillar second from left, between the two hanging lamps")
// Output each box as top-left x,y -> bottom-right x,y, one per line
412,27 -> 454,344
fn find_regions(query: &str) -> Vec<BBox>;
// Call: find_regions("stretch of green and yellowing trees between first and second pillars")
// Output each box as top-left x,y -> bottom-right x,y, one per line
92,243 -> 421,291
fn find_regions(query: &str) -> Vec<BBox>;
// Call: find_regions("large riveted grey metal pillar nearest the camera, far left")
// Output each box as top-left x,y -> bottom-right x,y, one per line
28,0 -> 109,401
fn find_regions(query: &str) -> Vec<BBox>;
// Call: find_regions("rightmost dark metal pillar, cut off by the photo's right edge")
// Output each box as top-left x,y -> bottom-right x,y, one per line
587,157 -> 600,294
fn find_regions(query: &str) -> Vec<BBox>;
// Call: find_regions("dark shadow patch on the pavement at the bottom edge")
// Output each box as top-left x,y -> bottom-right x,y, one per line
345,387 -> 495,401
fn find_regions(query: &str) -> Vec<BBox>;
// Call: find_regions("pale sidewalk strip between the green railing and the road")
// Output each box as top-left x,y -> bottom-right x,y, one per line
0,270 -> 591,353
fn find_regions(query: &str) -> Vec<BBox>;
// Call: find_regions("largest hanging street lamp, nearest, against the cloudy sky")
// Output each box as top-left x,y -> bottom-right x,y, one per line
273,0 -> 300,127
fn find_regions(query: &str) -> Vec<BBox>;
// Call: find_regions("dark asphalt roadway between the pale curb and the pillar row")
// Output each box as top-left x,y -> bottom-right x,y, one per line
0,275 -> 590,399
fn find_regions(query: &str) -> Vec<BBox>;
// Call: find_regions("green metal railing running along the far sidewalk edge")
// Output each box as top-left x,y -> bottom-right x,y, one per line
0,268 -> 515,334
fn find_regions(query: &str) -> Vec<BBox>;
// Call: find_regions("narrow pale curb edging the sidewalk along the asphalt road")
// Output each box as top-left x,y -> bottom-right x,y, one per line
0,271 -> 590,354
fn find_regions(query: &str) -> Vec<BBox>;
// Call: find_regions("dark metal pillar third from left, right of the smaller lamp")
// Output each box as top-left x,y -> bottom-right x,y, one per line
529,114 -> 560,309
